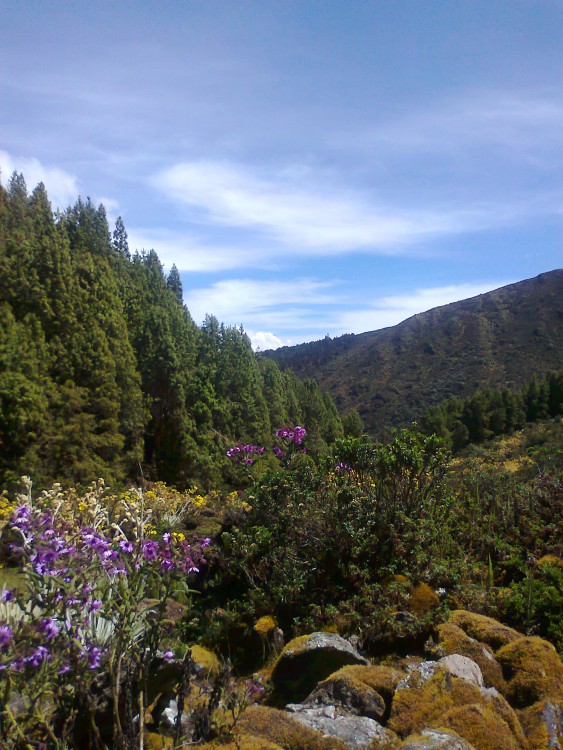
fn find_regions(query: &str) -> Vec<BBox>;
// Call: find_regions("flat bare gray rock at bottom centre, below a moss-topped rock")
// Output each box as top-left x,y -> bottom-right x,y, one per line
287,704 -> 395,750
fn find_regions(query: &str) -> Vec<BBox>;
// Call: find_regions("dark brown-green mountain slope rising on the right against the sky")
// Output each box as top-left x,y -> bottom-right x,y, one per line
264,269 -> 563,435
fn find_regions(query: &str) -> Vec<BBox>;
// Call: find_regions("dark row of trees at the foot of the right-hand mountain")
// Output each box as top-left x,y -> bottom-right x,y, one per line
421,371 -> 563,450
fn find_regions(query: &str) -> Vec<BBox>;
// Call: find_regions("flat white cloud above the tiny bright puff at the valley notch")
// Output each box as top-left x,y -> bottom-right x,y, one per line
184,279 -> 338,329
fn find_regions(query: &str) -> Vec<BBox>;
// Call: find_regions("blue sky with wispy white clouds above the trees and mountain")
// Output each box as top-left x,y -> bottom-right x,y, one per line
0,0 -> 563,349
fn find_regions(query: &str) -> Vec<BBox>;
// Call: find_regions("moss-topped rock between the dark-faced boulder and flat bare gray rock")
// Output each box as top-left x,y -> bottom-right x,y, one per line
305,665 -> 404,721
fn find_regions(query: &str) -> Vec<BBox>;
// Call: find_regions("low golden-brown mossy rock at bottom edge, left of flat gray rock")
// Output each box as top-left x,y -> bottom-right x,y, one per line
237,706 -> 347,750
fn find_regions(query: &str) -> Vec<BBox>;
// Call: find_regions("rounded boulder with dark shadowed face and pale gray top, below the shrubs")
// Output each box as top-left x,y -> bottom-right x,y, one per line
272,633 -> 369,703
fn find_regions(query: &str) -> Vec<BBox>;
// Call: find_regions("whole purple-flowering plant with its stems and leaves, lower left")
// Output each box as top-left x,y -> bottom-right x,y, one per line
0,478 -> 209,748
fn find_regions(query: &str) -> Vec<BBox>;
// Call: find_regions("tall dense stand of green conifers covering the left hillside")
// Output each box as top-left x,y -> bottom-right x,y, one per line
0,174 -> 342,494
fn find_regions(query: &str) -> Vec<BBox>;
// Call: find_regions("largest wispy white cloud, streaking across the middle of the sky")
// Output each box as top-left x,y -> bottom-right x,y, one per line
153,161 -> 479,255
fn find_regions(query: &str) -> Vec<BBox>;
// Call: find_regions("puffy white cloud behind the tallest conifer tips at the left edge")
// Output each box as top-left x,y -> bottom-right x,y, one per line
0,150 -> 80,209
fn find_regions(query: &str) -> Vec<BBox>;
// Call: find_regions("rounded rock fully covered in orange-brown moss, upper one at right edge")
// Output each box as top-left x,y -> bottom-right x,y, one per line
496,636 -> 563,708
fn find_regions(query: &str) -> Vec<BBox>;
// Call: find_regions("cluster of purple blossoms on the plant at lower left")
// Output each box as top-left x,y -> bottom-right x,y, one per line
0,505 -> 210,674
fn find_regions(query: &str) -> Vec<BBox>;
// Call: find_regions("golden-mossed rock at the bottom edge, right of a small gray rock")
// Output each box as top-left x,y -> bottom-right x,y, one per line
441,704 -> 526,750
